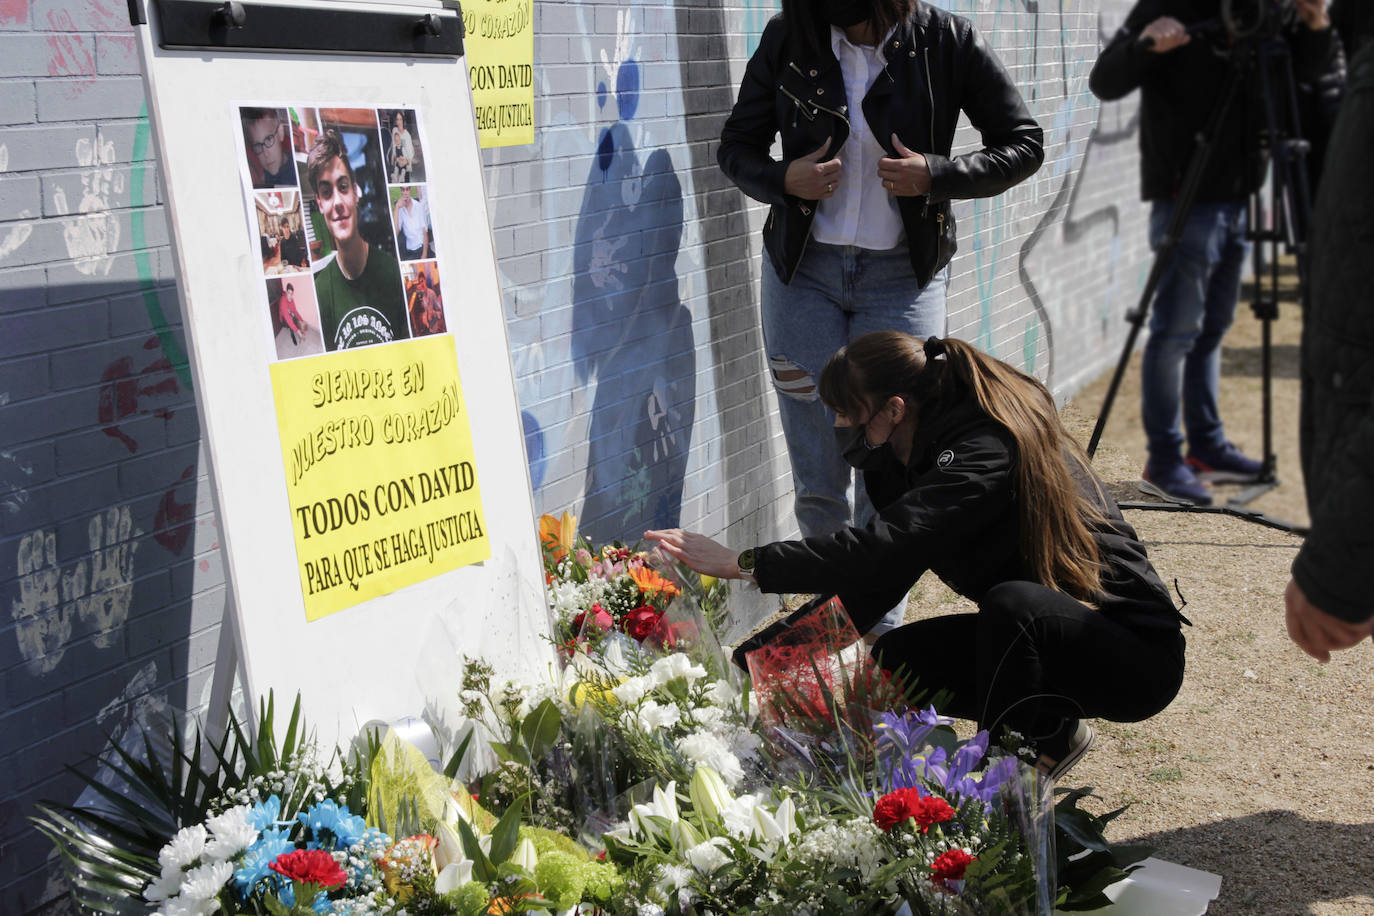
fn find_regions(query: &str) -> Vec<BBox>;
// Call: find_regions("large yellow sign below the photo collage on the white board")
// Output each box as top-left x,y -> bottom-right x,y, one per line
271,334 -> 492,621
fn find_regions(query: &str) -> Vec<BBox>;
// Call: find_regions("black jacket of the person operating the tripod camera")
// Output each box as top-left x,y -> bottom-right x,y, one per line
1088,0 -> 1341,202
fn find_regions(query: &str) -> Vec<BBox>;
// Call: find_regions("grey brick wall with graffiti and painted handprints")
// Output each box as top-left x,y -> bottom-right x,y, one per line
0,0 -> 1149,913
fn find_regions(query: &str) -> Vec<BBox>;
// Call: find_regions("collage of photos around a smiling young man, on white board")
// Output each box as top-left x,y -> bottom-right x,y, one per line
238,106 -> 448,360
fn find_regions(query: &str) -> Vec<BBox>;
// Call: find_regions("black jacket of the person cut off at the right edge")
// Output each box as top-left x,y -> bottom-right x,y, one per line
1293,44 -> 1374,623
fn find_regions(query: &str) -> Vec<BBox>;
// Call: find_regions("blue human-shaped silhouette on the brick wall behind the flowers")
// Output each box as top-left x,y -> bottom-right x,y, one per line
572,78 -> 697,542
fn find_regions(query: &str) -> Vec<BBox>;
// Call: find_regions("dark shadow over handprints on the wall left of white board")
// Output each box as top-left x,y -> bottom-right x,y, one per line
0,282 -> 214,913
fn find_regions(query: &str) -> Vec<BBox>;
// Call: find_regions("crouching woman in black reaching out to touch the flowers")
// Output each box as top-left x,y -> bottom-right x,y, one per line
646,331 -> 1183,779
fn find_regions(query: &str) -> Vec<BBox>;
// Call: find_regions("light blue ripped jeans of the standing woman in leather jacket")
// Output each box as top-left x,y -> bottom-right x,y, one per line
760,240 -> 949,636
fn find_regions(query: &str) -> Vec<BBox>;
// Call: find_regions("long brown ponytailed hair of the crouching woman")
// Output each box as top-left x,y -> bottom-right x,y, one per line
820,331 -> 1102,603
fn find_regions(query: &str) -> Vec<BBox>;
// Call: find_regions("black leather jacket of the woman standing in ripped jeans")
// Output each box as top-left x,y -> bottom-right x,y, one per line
717,1 -> 1044,286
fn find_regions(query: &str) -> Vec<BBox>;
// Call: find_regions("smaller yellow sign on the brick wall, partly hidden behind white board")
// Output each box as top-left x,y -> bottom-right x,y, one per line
463,0 -> 534,150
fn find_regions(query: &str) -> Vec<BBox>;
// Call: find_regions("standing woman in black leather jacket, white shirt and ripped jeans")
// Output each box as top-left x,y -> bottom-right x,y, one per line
719,0 -> 1044,634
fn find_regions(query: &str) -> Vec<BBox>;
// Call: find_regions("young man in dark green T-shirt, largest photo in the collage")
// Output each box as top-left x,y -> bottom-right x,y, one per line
305,128 -> 409,350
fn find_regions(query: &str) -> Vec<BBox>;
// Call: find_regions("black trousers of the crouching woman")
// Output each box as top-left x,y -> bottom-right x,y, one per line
872,582 -> 1183,740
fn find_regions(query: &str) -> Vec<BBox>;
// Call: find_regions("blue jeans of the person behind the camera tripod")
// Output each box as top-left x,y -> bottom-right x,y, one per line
1140,201 -> 1250,466
